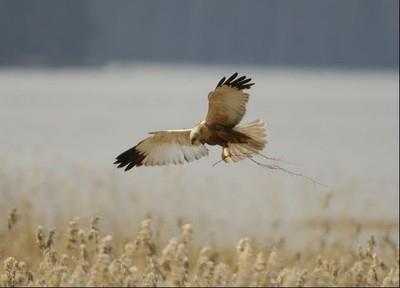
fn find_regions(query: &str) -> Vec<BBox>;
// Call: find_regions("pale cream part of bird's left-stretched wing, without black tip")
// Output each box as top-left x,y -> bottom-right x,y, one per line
136,129 -> 208,166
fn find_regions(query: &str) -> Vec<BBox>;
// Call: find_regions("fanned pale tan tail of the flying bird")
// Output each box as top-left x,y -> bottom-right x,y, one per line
222,120 -> 267,162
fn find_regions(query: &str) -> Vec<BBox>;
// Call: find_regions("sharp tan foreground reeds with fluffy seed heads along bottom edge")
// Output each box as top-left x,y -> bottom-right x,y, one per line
0,209 -> 399,287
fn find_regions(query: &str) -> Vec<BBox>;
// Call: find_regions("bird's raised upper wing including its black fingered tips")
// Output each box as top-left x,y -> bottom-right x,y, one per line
206,73 -> 254,127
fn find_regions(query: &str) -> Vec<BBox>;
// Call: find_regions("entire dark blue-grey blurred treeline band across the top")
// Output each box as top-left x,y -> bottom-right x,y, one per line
0,0 -> 399,68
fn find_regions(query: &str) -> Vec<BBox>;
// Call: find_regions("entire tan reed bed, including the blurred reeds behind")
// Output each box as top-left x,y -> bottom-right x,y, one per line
0,165 -> 399,287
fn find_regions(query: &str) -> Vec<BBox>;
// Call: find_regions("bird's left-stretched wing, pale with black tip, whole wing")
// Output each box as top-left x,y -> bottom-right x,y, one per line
114,129 -> 208,171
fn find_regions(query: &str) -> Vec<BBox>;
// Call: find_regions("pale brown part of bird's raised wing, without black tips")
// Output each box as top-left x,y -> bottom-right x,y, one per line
206,85 -> 249,126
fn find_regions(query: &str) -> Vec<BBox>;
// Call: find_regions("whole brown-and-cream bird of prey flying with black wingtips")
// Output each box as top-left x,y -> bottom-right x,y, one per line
114,73 -> 267,171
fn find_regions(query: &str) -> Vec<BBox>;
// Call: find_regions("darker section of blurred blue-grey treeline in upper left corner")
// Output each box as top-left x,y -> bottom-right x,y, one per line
0,0 -> 94,66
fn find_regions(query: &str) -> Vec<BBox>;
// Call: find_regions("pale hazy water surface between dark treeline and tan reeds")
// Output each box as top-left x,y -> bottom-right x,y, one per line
0,65 -> 399,245
